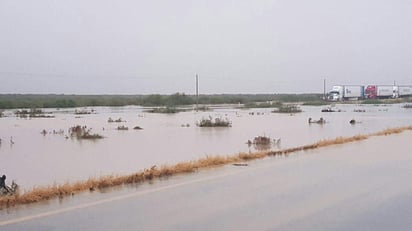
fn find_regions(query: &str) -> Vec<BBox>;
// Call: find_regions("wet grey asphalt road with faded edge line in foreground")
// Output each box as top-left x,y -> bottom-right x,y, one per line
0,133 -> 412,231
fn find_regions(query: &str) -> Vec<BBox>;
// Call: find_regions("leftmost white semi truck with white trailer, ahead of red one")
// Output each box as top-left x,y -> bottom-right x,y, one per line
328,85 -> 365,101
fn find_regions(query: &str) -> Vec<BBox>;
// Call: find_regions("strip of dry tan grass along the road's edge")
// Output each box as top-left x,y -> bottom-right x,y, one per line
0,126 -> 412,208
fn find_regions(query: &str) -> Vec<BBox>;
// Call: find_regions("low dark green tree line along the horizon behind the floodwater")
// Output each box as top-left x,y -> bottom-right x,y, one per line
0,93 -> 322,109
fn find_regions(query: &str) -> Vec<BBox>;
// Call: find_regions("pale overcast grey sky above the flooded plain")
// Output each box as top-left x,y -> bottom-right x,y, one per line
0,0 -> 412,94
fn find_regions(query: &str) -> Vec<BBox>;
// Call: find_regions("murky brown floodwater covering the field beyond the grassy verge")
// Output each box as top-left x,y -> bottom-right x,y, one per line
0,104 -> 412,189
